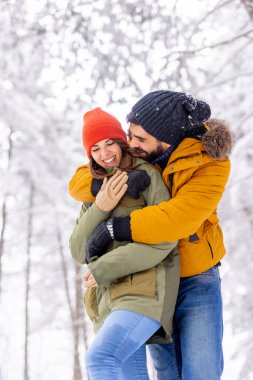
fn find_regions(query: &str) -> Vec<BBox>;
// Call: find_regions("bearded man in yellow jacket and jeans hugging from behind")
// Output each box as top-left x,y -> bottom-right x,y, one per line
70,91 -> 232,380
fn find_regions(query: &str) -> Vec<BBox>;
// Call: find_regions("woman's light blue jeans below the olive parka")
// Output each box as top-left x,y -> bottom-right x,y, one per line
86,310 -> 161,380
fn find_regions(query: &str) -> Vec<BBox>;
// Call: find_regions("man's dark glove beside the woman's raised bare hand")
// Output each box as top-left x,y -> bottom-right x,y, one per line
126,170 -> 150,199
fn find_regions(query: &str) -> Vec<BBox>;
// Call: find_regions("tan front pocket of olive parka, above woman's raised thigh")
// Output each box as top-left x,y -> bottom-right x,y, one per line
110,268 -> 156,301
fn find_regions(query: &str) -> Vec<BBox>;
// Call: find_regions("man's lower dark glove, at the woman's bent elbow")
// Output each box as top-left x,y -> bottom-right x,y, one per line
85,219 -> 113,264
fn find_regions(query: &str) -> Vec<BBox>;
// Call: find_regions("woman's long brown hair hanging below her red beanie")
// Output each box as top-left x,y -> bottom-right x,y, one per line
89,139 -> 136,179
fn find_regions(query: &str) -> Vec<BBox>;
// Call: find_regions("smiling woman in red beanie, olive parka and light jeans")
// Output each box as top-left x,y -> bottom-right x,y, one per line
70,108 -> 179,380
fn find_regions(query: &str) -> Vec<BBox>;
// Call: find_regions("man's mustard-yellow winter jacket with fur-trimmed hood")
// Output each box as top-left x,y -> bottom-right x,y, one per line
69,122 -> 232,277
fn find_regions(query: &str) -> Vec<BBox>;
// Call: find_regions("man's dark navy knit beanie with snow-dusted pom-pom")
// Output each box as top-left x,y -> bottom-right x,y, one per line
127,91 -> 211,148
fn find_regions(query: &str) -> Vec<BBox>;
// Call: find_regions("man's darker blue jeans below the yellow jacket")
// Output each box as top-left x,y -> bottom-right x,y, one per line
149,267 -> 223,380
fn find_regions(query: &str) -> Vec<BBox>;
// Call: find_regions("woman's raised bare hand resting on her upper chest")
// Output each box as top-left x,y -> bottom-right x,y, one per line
95,170 -> 128,211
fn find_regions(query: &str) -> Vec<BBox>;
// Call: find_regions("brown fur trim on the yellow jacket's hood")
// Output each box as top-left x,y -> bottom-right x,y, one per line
202,119 -> 234,160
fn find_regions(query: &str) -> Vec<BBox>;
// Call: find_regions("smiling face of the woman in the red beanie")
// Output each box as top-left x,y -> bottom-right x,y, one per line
91,139 -> 122,168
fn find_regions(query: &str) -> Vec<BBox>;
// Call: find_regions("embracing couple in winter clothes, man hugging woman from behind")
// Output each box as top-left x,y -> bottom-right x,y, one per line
69,91 -> 232,380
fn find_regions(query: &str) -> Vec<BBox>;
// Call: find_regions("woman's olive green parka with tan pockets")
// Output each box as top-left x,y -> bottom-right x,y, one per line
70,159 -> 180,343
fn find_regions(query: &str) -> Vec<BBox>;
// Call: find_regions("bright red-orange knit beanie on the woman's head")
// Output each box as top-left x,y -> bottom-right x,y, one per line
83,107 -> 127,158
